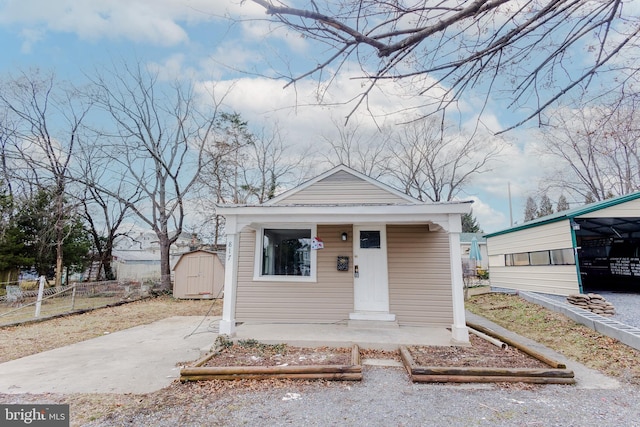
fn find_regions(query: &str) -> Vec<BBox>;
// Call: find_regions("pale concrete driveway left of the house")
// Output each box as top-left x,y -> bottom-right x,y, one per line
0,316 -> 217,394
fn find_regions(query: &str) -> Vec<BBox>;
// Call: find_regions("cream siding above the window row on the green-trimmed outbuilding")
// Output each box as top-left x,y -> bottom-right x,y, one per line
487,220 -> 573,256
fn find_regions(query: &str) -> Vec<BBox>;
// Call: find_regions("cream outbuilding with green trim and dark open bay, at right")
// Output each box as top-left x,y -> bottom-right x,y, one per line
485,193 -> 640,295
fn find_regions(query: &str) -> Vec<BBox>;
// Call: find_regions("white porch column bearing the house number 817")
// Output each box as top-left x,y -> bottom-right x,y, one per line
219,224 -> 239,337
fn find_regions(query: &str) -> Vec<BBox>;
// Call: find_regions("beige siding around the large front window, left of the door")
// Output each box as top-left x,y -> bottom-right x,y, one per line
236,225 -> 353,323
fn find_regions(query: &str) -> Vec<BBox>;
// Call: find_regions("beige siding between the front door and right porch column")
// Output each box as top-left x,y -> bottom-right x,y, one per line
387,225 -> 453,326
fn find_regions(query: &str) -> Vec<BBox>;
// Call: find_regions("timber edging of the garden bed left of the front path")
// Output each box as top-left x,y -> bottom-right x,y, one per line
180,345 -> 362,381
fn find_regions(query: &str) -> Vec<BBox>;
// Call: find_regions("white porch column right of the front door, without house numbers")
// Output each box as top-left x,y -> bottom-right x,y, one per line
449,214 -> 469,342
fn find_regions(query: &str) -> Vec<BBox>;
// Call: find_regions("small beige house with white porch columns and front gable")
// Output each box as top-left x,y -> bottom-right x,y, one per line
217,166 -> 470,342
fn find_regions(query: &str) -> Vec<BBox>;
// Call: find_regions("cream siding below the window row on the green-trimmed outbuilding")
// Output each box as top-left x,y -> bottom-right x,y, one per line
489,265 -> 580,295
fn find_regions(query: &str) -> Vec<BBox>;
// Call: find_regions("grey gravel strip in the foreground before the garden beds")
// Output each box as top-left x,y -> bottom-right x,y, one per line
88,367 -> 640,427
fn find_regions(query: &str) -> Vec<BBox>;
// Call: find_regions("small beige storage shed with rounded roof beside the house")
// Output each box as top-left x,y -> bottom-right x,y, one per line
173,250 -> 224,299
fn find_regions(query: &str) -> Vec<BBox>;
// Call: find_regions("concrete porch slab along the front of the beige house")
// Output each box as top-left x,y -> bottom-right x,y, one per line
234,323 -> 453,350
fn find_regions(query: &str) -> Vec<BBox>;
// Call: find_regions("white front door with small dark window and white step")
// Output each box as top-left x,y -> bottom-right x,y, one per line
350,225 -> 395,320
